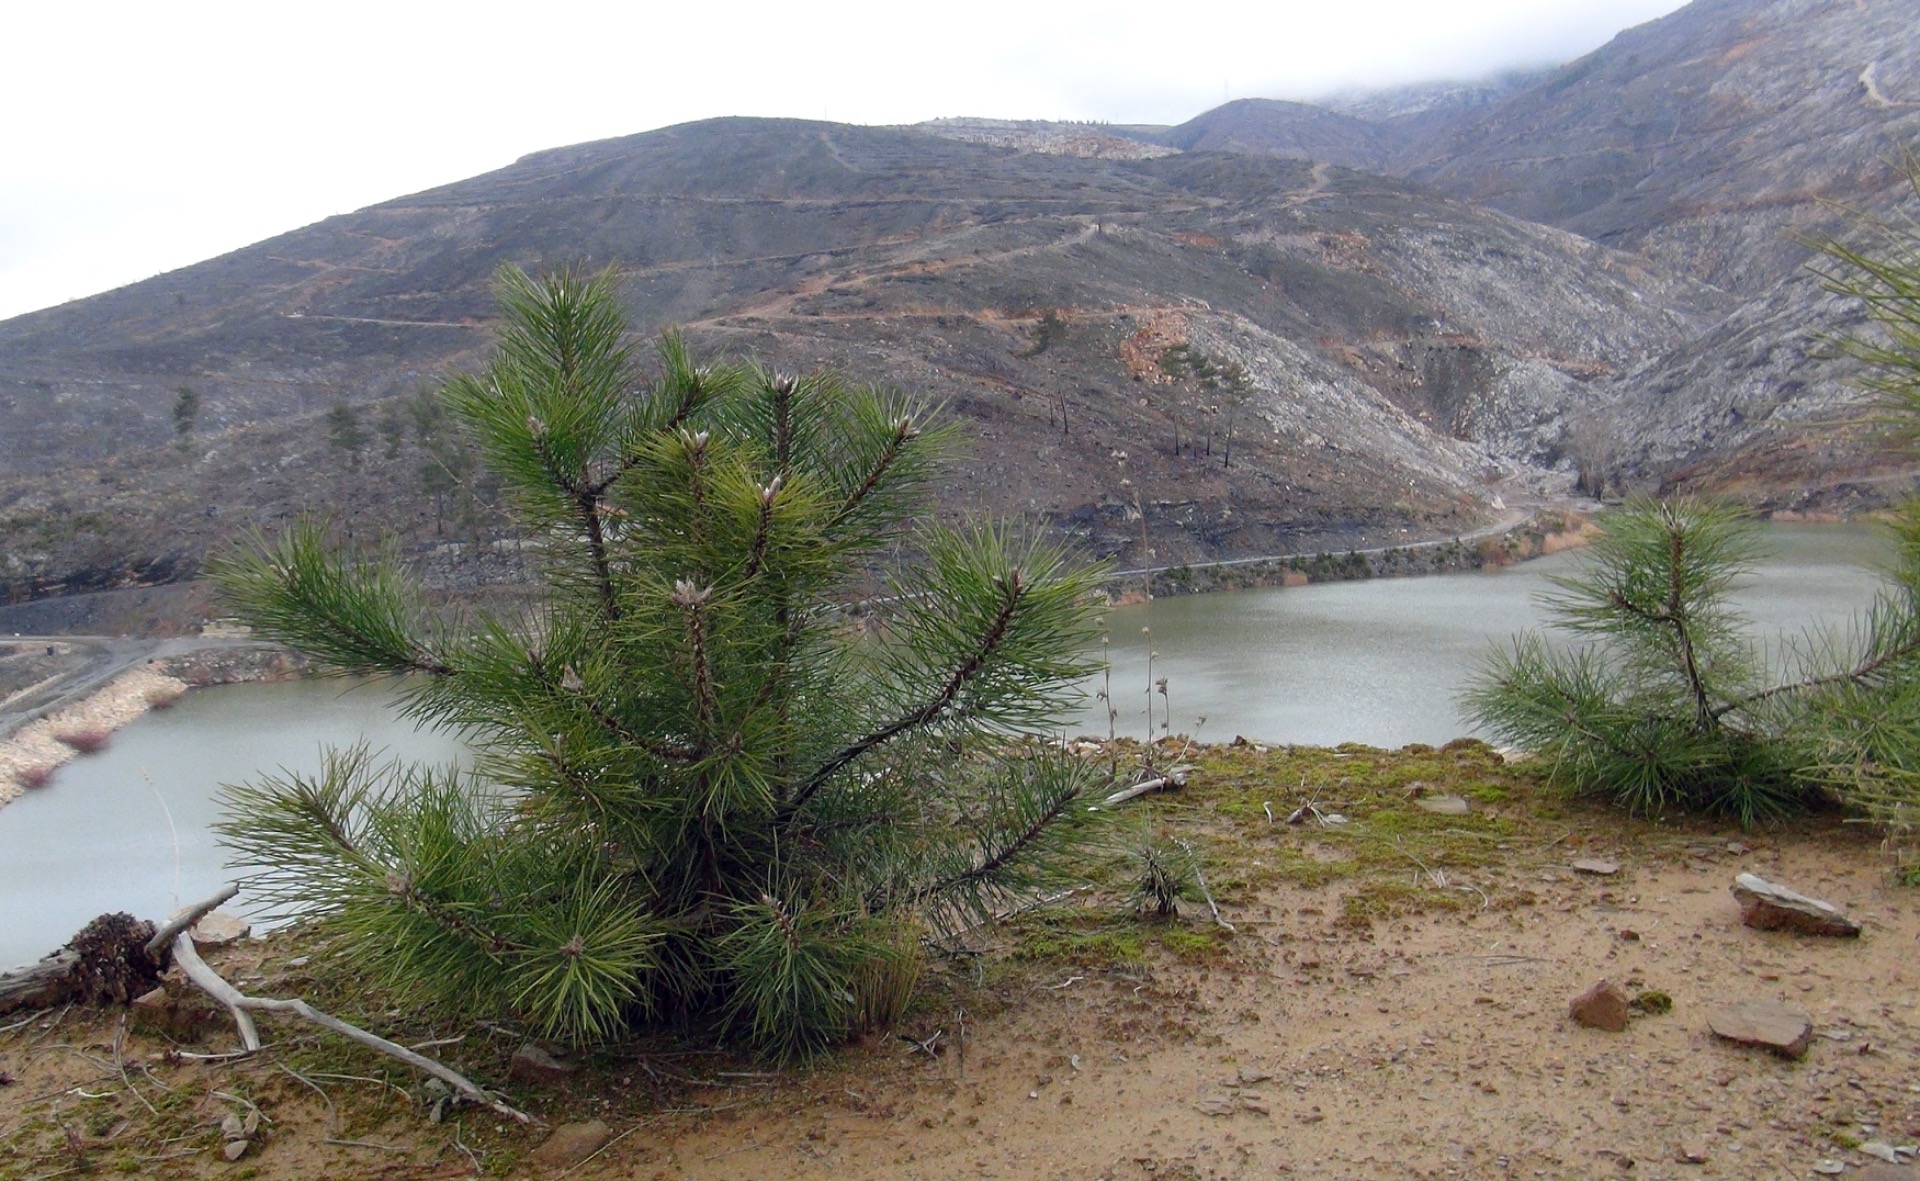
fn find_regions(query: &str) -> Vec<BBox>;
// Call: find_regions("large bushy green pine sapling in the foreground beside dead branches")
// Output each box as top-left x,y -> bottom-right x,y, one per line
215,271 -> 1096,1056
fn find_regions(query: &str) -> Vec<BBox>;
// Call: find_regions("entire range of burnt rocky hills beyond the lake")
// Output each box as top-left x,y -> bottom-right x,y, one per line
0,0 -> 1920,614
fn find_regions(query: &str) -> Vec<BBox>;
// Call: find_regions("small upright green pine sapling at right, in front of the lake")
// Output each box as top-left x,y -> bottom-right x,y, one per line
1465,499 -> 1805,824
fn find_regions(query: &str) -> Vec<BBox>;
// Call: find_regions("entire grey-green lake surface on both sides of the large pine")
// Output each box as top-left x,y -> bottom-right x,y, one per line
0,526 -> 1885,968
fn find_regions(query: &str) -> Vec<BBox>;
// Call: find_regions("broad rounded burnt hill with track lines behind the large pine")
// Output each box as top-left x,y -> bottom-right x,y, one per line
0,119 -> 1713,597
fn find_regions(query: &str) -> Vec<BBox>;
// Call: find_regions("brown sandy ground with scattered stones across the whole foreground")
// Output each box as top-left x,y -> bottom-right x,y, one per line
0,756 -> 1920,1181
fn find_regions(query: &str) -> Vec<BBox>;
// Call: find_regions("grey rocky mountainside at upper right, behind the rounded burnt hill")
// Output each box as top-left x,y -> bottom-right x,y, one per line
1128,0 -> 1920,503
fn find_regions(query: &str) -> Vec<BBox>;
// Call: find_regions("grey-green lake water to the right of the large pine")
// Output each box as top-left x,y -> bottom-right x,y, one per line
1073,526 -> 1887,747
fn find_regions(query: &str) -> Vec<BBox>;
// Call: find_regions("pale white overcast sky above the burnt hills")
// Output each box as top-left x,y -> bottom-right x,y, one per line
0,0 -> 1682,319
